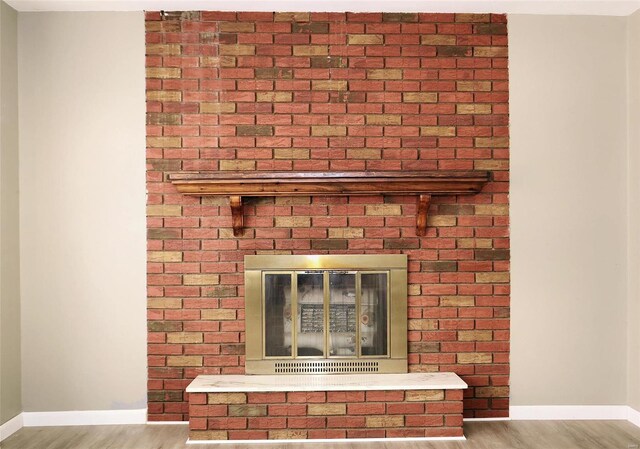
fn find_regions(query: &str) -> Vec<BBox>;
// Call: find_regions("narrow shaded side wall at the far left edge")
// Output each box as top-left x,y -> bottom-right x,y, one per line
0,1 -> 22,424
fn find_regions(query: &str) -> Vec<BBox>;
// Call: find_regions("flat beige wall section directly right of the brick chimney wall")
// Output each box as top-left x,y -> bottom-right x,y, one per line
509,16 -> 627,405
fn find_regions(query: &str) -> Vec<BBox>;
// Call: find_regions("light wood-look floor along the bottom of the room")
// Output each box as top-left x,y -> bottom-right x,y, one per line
0,421 -> 640,449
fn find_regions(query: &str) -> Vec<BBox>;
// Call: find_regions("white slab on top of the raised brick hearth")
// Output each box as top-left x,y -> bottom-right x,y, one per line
187,373 -> 467,393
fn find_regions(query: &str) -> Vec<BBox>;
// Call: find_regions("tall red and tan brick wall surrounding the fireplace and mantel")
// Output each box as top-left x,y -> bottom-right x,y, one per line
146,12 -> 509,420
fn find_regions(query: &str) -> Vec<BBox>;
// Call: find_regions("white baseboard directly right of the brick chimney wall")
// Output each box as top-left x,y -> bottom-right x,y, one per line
509,405 -> 630,420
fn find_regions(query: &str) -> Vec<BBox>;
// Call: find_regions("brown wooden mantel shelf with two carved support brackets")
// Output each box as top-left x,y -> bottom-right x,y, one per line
169,171 -> 490,236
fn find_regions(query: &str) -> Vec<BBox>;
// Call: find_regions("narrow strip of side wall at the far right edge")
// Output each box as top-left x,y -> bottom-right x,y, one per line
627,12 -> 640,411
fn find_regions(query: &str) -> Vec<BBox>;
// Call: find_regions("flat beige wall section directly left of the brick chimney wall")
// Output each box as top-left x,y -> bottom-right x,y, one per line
19,12 -> 146,411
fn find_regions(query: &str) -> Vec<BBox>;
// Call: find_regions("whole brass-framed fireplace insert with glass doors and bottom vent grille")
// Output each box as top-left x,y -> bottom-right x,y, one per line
245,255 -> 407,374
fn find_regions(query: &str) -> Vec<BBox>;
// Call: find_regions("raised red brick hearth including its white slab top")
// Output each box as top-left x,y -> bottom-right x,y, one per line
187,373 -> 466,442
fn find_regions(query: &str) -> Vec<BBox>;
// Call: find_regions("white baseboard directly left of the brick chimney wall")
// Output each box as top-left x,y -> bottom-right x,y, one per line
22,409 -> 147,427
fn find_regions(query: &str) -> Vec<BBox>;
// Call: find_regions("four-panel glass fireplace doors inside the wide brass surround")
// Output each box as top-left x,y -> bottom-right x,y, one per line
263,270 -> 389,359
